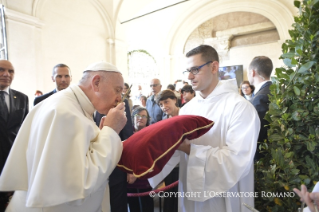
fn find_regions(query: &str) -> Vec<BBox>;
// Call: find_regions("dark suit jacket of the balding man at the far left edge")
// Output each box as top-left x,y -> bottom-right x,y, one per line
0,89 -> 29,173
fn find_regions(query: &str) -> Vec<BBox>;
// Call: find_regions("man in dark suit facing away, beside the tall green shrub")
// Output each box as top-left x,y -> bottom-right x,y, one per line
248,56 -> 273,161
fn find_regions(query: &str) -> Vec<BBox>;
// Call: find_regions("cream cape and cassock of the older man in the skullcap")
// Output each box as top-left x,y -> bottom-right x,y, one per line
0,85 -> 123,212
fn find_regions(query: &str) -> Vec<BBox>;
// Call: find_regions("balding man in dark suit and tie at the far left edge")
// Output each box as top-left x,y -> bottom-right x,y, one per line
0,60 -> 29,211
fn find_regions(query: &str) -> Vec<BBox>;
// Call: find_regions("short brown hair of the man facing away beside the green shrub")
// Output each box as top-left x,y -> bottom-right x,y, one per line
249,56 -> 273,79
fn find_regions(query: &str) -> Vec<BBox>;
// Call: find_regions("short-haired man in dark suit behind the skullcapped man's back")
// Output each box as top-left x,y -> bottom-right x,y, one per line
33,63 -> 72,105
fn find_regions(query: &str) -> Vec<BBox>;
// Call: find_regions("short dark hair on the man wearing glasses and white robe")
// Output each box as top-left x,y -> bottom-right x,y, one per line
186,45 -> 219,62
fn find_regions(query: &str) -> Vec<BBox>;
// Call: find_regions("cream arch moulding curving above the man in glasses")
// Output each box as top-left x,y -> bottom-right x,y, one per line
164,0 -> 293,81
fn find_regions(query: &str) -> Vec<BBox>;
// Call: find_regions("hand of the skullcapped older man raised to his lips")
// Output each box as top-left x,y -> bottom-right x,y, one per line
101,102 -> 127,134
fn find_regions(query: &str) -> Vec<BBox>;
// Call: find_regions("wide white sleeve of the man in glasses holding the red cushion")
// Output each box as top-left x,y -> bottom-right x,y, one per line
187,100 -> 260,201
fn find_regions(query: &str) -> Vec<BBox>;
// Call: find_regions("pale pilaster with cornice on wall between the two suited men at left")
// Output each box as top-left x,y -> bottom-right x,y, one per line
6,9 -> 44,104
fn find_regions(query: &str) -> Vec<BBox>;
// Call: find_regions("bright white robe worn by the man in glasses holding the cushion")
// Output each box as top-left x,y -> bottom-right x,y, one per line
149,79 -> 260,212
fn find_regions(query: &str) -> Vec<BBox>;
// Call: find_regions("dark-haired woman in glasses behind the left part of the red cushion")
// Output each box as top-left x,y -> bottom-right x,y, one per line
127,107 -> 154,212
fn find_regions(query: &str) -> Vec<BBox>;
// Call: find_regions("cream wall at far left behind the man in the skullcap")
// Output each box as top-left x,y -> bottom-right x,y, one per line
6,0 -> 115,106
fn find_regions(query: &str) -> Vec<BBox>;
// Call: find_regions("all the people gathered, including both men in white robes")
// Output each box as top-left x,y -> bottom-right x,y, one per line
0,45 -> 318,212
